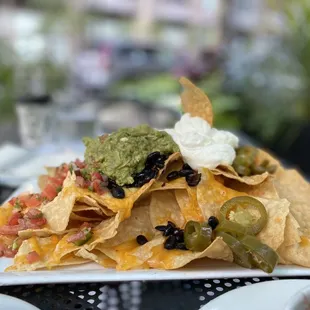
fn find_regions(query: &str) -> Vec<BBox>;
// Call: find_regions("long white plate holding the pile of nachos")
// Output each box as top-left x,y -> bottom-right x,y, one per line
0,179 -> 310,285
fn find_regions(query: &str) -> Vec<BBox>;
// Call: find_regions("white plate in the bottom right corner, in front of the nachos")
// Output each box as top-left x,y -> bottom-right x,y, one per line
201,280 -> 310,310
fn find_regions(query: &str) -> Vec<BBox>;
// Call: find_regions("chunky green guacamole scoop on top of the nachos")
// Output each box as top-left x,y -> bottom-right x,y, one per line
83,125 -> 180,186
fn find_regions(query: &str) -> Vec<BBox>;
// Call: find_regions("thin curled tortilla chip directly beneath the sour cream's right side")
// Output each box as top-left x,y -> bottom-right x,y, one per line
211,165 -> 269,186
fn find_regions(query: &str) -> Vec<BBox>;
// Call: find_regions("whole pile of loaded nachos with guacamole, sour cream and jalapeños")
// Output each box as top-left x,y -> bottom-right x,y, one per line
0,78 -> 310,273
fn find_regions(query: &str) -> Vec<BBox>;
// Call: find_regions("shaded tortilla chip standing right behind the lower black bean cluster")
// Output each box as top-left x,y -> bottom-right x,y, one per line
150,191 -> 185,228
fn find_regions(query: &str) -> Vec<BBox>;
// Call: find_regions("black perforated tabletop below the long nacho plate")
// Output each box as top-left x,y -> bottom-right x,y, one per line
0,277 -> 310,310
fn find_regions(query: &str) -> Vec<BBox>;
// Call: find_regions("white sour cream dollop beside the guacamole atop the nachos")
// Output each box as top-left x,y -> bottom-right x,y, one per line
166,113 -> 239,169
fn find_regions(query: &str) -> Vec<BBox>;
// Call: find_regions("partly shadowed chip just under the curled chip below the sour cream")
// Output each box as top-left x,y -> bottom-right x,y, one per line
224,178 -> 279,200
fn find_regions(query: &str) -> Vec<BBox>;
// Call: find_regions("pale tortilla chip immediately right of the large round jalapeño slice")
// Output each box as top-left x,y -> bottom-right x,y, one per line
256,197 -> 290,250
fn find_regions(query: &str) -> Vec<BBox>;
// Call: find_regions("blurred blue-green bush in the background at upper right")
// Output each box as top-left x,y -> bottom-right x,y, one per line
226,0 -> 310,148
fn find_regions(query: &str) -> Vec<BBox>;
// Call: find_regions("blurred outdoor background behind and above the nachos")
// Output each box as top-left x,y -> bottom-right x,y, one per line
0,0 -> 310,182
